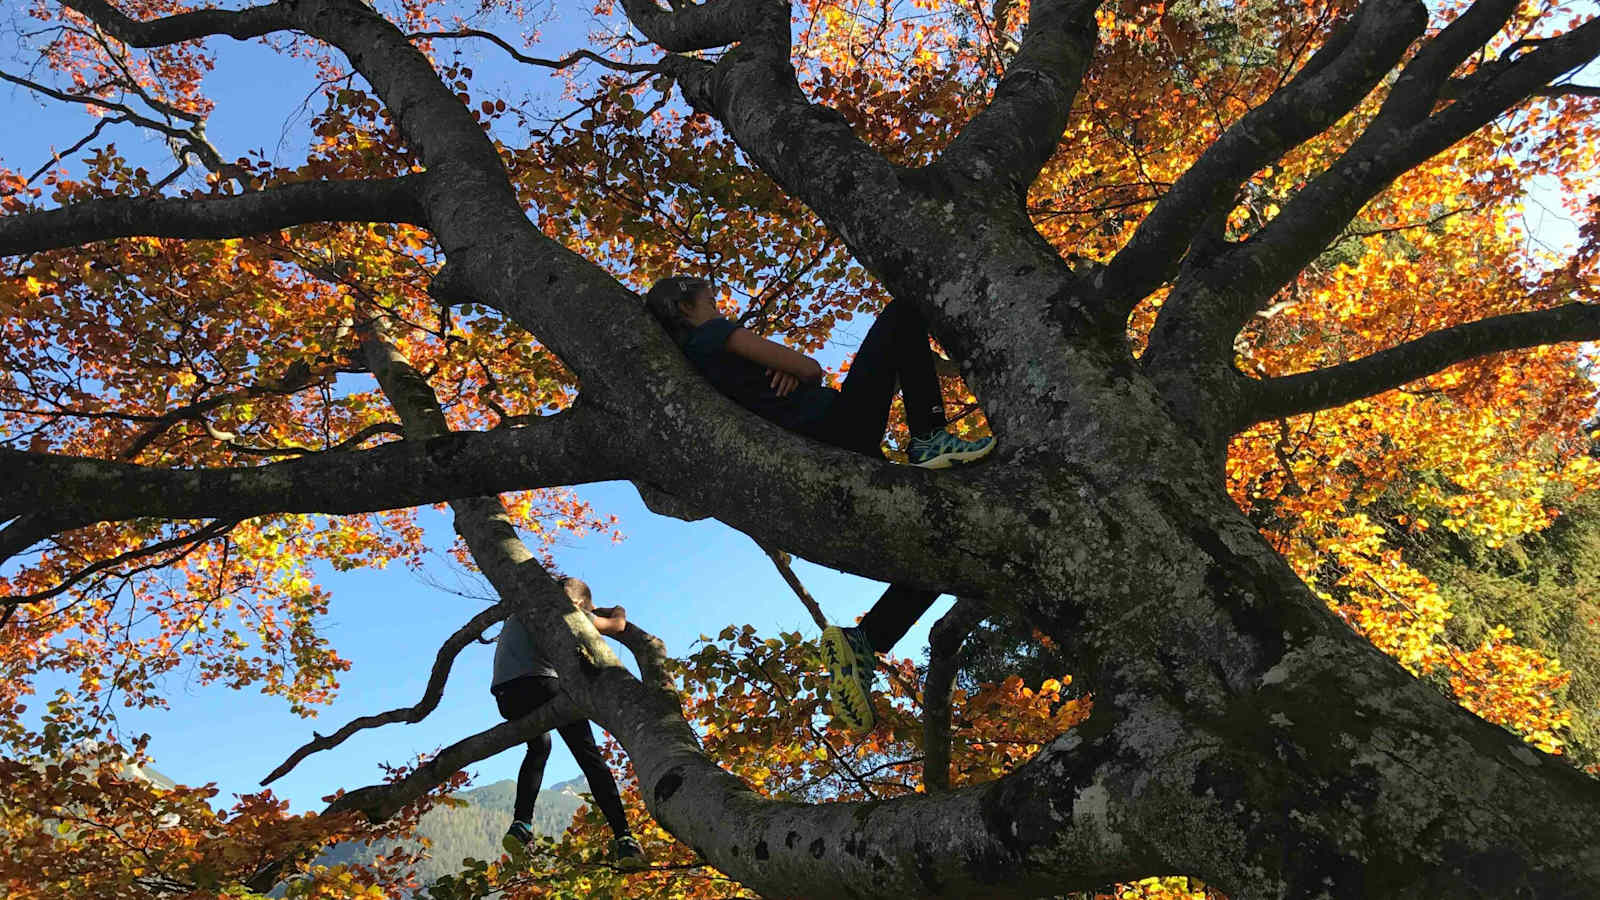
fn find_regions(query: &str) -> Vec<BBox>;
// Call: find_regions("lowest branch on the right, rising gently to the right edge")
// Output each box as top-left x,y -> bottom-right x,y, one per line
1243,303 -> 1600,426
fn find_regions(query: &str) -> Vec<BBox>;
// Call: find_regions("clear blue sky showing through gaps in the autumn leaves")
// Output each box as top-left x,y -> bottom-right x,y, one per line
0,5 -> 1594,810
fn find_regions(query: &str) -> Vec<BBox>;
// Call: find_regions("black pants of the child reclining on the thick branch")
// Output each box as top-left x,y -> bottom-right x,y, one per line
808,303 -> 946,653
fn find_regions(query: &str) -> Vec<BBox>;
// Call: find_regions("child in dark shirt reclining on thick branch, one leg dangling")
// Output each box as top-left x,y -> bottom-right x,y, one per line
645,275 -> 994,733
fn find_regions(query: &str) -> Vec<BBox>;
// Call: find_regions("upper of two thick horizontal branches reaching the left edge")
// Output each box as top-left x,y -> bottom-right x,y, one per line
0,175 -> 427,256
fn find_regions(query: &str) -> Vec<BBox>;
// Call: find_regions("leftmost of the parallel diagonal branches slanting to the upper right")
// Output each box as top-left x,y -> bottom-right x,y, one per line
1102,0 -> 1427,315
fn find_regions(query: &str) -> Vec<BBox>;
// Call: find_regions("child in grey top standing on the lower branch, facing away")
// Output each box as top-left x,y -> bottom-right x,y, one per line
490,578 -> 645,868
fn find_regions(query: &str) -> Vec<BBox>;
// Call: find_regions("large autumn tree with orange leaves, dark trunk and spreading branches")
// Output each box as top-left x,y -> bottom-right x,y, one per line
0,0 -> 1600,898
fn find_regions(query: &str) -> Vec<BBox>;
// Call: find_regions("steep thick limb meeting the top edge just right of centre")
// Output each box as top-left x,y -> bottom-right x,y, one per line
942,0 -> 1101,190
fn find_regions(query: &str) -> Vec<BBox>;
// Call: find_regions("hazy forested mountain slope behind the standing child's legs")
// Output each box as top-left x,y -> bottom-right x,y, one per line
308,775 -> 589,884
